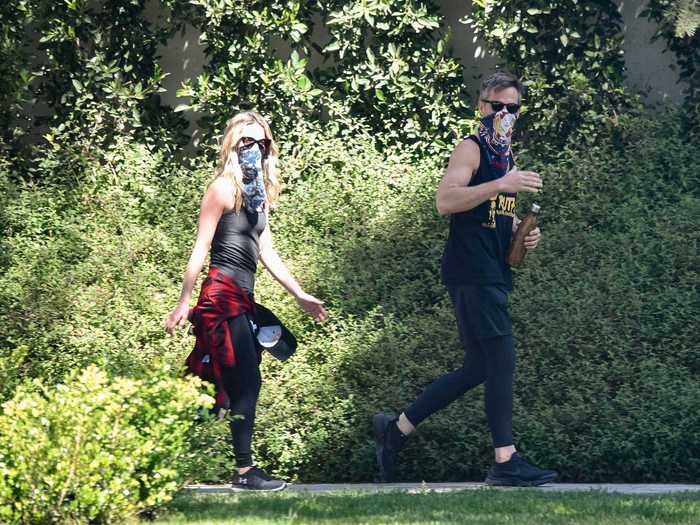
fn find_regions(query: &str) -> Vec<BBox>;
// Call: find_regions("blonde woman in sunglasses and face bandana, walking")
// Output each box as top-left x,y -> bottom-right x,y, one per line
165,111 -> 327,491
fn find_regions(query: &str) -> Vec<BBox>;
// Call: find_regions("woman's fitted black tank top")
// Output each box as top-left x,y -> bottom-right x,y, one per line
210,207 -> 267,293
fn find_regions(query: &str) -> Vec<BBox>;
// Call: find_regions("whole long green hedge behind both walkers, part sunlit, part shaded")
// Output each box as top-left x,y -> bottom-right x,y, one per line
0,111 -> 700,481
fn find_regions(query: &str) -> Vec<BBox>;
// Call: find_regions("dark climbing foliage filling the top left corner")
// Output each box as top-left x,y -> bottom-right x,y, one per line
0,0 -> 186,164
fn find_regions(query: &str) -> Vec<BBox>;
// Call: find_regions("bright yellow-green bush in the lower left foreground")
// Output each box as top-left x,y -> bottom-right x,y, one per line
0,367 -> 212,524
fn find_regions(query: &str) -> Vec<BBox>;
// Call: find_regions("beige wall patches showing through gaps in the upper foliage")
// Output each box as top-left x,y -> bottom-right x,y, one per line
153,0 -> 682,131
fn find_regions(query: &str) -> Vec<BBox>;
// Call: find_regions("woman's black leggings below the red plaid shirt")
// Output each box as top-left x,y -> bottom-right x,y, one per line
222,314 -> 262,468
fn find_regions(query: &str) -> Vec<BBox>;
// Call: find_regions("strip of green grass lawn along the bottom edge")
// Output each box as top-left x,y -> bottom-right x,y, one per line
156,489 -> 700,525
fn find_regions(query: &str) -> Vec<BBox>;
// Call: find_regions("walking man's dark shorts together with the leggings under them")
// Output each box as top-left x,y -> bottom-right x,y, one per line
404,286 -> 515,447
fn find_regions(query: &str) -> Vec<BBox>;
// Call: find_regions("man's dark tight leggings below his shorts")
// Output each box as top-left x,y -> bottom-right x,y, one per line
404,290 -> 515,447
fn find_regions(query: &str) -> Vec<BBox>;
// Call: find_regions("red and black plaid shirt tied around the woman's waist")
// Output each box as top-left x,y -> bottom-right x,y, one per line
185,268 -> 260,408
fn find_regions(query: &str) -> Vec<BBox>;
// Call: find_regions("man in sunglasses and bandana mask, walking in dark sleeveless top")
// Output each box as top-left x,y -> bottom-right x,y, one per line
373,71 -> 557,486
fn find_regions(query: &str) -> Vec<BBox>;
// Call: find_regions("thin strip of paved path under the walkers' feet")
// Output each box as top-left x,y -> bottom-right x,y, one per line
185,483 -> 700,495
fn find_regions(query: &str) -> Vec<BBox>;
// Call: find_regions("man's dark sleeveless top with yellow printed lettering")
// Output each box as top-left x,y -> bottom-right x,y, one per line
442,135 -> 516,290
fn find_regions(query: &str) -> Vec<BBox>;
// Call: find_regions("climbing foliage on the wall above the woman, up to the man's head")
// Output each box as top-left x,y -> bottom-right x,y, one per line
170,0 -> 472,154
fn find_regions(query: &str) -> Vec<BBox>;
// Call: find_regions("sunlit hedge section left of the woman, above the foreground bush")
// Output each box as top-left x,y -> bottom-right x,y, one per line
0,139 -> 205,396
